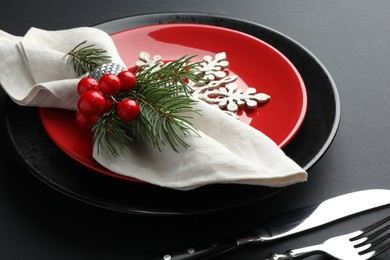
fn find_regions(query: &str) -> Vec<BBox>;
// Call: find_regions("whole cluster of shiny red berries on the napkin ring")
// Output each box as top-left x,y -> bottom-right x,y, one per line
76,70 -> 140,128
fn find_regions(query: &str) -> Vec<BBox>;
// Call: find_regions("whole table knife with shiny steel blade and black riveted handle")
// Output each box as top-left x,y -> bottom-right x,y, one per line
150,189 -> 390,260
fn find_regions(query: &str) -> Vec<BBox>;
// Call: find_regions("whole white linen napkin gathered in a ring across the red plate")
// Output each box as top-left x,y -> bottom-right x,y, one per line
0,27 -> 307,190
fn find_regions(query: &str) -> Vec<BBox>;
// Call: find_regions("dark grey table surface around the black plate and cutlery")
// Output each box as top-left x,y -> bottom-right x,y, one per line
0,0 -> 390,260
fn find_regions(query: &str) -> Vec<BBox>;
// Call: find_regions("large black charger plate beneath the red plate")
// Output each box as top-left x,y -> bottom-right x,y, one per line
4,13 -> 340,215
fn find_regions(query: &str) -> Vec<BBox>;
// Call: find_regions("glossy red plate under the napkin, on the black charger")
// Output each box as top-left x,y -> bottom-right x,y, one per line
40,24 -> 307,182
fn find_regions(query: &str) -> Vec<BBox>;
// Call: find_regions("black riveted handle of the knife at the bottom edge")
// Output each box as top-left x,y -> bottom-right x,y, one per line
150,237 -> 239,260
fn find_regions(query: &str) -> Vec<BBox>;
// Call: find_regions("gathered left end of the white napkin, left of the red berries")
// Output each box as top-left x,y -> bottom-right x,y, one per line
0,27 -> 124,110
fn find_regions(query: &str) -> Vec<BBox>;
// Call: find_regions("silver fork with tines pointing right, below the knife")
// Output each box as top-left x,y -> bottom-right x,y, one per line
263,216 -> 390,260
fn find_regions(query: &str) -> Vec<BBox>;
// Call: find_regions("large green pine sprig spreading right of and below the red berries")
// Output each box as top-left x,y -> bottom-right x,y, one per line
93,57 -> 201,156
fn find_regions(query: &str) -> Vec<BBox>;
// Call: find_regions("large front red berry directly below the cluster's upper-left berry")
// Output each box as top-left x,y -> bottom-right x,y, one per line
77,90 -> 106,115
